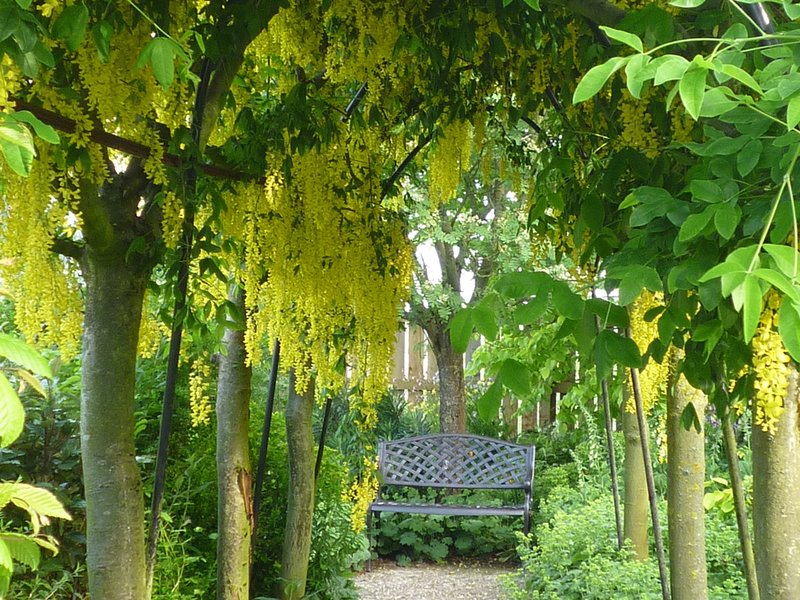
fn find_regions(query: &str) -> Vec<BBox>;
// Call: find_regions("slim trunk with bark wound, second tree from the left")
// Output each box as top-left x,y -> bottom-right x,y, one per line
216,289 -> 253,600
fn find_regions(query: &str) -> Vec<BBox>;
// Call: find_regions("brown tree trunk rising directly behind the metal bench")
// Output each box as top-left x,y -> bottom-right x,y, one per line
426,326 -> 467,433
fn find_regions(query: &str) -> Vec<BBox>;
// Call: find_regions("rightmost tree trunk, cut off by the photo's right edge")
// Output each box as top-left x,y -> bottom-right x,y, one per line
752,369 -> 800,600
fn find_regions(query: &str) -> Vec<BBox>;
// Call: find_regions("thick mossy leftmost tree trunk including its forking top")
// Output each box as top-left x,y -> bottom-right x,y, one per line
76,161 -> 151,600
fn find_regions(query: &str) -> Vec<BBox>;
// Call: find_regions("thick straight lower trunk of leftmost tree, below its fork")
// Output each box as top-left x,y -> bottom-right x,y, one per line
81,247 -> 148,600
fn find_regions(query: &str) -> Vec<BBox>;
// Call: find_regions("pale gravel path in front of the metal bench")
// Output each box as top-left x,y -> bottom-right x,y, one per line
355,561 -> 513,600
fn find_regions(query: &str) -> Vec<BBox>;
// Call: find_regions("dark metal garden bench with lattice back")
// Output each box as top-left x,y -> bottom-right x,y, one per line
367,434 -> 536,564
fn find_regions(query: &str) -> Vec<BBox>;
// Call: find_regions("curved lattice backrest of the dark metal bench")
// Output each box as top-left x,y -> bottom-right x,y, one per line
379,434 -> 532,489
